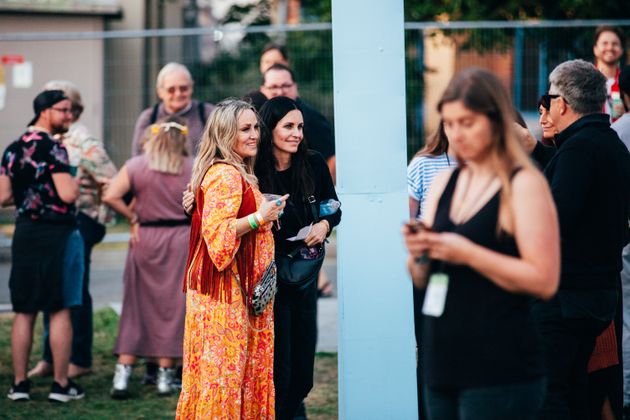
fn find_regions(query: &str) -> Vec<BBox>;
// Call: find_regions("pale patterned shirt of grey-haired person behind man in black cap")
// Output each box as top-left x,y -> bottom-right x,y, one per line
63,123 -> 116,224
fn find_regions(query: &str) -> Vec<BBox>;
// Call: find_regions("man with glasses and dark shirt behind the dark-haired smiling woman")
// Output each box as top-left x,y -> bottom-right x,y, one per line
260,63 -> 336,181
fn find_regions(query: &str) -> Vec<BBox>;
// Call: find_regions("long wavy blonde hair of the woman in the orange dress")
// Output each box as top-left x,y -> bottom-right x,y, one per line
190,98 -> 258,191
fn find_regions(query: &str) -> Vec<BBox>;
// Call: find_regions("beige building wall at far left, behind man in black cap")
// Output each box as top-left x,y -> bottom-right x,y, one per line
0,14 -> 104,155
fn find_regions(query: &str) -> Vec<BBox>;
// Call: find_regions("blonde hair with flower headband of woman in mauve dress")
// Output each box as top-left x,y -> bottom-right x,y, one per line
143,116 -> 188,175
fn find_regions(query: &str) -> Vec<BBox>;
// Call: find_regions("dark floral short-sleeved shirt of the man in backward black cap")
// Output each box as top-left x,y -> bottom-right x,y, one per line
0,130 -> 75,221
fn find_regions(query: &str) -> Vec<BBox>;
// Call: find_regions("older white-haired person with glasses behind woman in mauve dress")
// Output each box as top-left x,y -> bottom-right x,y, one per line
131,63 -> 214,156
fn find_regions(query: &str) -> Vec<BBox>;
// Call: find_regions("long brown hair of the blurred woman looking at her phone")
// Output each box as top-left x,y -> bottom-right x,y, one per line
437,68 -> 533,227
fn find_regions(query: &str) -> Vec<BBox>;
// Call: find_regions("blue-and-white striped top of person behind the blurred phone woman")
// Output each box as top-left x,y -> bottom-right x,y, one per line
407,153 -> 457,216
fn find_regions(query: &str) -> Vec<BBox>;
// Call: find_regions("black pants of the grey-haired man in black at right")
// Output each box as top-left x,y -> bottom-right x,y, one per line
533,299 -> 610,420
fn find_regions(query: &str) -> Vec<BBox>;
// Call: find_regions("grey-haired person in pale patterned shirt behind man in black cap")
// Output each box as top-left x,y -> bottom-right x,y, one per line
28,80 -> 116,378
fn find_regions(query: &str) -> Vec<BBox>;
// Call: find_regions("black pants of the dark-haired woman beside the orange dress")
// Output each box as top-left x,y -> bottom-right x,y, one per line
273,277 -> 317,420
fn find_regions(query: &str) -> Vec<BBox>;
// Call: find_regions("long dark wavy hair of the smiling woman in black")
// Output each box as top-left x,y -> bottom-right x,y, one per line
254,96 -> 315,200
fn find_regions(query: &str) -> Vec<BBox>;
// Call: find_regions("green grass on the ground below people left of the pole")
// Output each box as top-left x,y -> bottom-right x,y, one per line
0,309 -> 337,420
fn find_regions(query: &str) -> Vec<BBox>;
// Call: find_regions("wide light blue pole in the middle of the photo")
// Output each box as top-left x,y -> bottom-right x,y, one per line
332,0 -> 417,420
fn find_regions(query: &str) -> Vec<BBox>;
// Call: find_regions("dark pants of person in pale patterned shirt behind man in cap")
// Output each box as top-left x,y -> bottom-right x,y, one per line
43,212 -> 105,368
